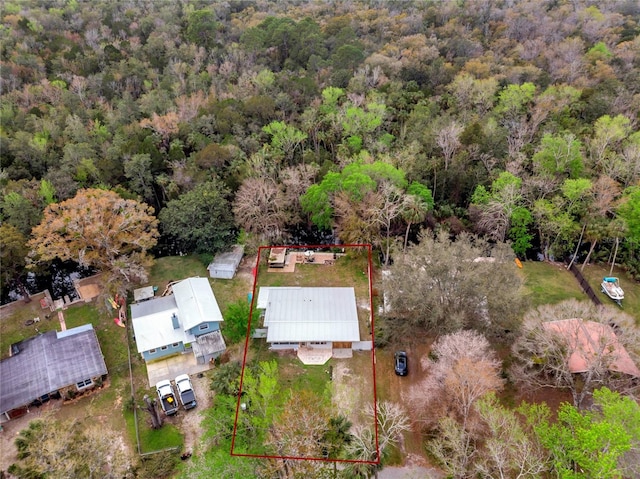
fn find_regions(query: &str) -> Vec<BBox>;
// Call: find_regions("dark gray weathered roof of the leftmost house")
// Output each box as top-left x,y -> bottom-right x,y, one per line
0,324 -> 107,413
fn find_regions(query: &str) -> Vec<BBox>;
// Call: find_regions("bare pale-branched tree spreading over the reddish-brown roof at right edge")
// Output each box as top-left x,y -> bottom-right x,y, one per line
510,300 -> 640,408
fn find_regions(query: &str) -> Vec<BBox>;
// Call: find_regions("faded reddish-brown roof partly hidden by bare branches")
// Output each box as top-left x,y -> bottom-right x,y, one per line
543,318 -> 640,377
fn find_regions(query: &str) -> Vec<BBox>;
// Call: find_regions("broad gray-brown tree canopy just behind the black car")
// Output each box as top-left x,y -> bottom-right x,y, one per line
383,231 -> 522,337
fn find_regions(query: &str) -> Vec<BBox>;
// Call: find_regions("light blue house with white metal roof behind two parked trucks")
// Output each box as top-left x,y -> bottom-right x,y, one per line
131,278 -> 226,364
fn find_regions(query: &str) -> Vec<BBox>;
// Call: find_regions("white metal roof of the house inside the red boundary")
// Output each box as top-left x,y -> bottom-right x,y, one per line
264,287 -> 360,343
